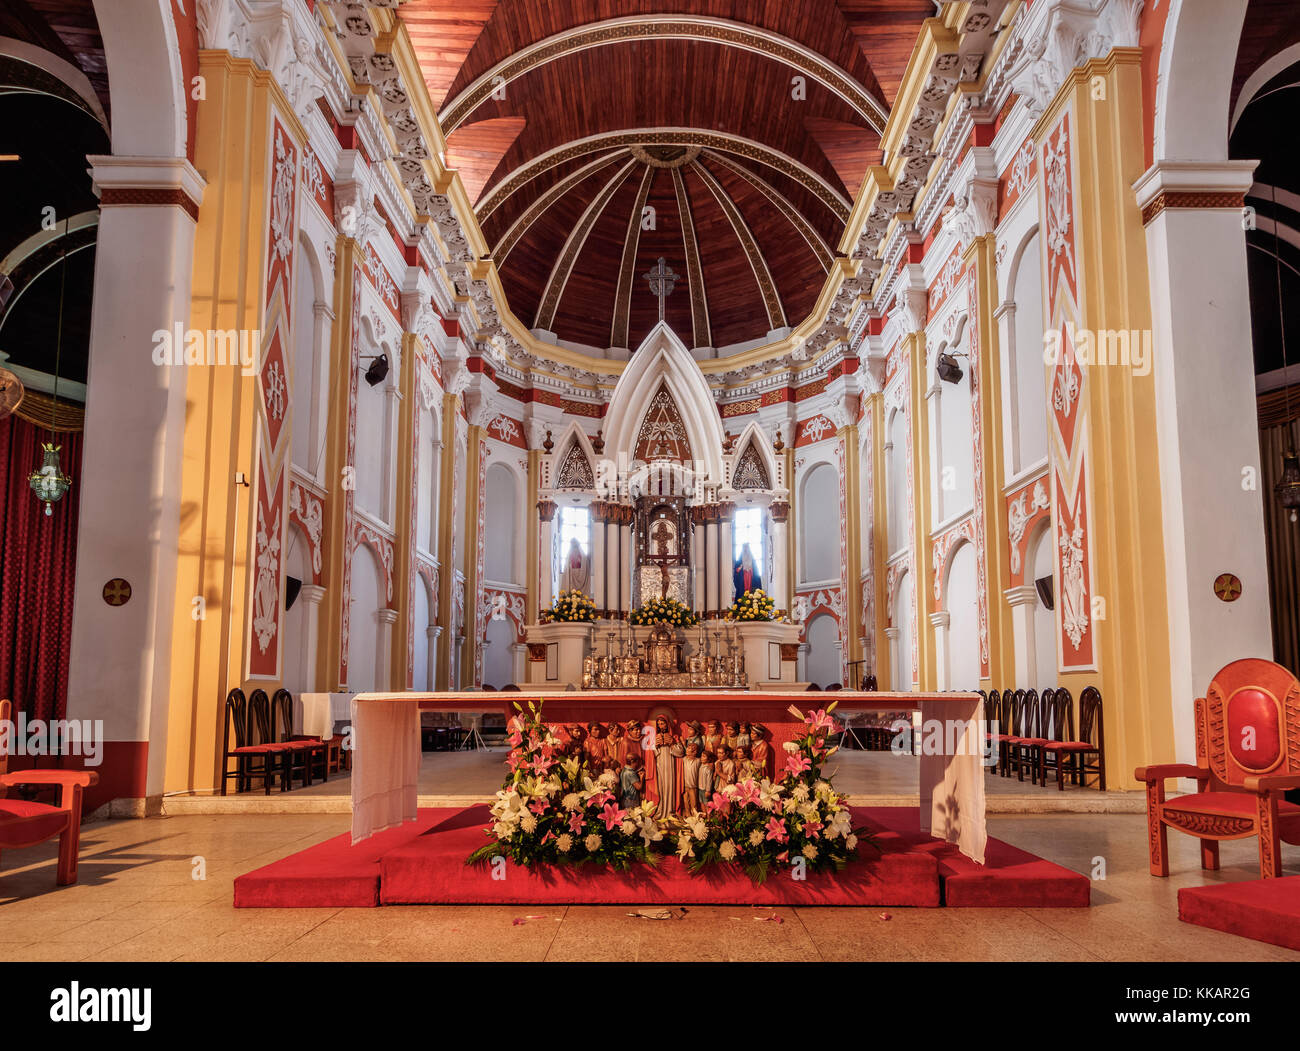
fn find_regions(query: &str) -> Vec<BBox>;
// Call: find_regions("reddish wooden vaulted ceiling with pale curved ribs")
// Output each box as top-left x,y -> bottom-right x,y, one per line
400,0 -> 935,347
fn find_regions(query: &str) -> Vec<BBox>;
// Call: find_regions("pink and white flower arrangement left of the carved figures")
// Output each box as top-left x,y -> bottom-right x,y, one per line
468,701 -> 663,870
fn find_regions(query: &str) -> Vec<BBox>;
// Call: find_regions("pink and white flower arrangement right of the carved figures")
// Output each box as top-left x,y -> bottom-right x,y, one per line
675,704 -> 870,883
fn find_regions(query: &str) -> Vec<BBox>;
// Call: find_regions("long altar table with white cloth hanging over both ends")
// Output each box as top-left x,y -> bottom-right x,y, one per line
352,689 -> 988,864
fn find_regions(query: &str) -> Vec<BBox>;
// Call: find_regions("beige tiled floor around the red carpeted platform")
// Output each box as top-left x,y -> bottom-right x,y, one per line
0,806 -> 1300,961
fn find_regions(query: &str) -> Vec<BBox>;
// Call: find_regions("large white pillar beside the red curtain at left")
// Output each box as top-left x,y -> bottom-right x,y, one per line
65,156 -> 204,795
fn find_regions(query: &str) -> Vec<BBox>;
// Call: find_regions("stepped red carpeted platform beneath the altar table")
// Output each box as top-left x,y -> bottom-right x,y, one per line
235,805 -> 1088,908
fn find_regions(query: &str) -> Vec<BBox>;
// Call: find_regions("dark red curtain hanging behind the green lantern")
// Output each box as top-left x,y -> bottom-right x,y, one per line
0,416 -> 82,719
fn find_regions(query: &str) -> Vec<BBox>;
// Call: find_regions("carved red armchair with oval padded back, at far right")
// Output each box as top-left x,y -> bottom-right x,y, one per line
1134,658 -> 1300,878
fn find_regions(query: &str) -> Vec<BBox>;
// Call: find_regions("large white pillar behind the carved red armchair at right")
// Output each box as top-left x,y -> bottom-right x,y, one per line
1135,159 -> 1273,762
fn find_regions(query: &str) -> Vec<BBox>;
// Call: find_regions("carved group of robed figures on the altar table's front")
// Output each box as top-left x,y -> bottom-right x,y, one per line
556,715 -> 772,818
